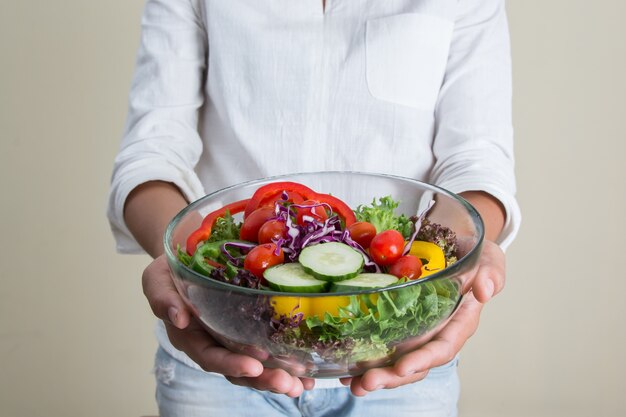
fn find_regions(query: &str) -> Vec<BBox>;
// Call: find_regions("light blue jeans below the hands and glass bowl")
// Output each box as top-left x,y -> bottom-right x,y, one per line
155,348 -> 459,417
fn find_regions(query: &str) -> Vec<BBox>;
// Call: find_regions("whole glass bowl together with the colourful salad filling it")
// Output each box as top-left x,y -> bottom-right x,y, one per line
165,172 -> 484,378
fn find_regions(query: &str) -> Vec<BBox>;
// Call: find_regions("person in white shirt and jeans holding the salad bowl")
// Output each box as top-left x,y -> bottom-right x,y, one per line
108,0 -> 520,416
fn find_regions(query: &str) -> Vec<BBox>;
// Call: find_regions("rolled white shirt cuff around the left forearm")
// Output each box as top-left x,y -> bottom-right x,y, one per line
107,159 -> 205,254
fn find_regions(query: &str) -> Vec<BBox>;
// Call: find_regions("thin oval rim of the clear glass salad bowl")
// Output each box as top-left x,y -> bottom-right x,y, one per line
163,171 -> 485,298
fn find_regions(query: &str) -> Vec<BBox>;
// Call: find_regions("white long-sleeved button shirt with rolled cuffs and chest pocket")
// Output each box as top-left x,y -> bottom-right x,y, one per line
108,0 -> 520,384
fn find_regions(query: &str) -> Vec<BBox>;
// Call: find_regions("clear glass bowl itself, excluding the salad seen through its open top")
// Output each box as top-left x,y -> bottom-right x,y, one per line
164,172 -> 484,378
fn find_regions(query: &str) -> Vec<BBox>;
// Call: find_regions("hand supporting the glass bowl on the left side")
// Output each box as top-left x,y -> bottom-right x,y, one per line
142,255 -> 315,398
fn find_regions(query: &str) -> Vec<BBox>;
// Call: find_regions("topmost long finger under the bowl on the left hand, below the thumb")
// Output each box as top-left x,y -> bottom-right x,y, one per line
165,320 -> 263,377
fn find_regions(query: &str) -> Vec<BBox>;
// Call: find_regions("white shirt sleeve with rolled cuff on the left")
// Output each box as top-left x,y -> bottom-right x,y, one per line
107,0 -> 207,253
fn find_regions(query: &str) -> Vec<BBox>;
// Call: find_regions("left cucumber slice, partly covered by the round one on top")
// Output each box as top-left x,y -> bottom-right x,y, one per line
263,263 -> 328,293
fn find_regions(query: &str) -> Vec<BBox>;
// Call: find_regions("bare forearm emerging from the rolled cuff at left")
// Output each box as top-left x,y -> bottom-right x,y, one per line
124,181 -> 187,258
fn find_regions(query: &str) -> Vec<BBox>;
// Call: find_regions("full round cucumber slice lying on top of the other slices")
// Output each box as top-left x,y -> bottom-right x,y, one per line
298,242 -> 364,282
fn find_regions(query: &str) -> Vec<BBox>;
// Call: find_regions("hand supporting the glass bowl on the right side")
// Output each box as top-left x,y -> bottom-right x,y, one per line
341,240 -> 505,396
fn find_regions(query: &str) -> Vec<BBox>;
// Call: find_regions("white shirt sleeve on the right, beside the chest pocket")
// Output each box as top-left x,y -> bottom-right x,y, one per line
431,0 -> 521,249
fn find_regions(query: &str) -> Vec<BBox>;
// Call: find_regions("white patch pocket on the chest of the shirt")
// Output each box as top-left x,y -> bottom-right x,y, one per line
365,13 -> 453,110
